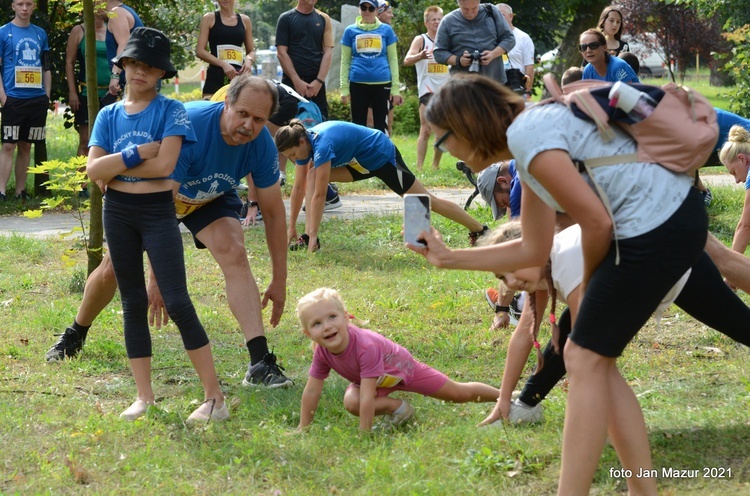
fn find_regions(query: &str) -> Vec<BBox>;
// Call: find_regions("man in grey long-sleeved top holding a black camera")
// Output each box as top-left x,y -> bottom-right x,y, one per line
433,0 -> 516,84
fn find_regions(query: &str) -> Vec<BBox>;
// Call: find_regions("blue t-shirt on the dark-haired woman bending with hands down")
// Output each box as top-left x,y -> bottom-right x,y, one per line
297,121 -> 396,174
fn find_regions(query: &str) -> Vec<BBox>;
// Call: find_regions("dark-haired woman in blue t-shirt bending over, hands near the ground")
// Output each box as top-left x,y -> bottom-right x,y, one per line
275,119 -> 488,252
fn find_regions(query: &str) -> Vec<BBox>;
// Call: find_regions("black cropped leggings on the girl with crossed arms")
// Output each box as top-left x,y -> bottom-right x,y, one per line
103,189 -> 208,358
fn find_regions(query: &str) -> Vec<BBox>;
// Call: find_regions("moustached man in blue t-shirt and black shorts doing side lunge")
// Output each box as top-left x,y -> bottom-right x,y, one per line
46,74 -> 292,388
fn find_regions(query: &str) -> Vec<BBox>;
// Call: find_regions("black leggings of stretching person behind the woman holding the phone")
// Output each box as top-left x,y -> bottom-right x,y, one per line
519,252 -> 750,406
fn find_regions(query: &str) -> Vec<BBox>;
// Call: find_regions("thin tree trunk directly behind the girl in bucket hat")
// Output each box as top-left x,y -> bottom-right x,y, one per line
83,0 -> 104,274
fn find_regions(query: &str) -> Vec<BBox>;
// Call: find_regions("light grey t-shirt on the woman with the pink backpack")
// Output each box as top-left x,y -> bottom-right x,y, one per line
507,103 -> 693,239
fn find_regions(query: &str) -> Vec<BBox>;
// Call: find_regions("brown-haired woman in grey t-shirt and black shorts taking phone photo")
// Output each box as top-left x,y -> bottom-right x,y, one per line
410,75 -> 750,495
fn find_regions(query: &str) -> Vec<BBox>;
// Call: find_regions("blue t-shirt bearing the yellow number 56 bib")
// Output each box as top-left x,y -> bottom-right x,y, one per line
0,22 -> 49,99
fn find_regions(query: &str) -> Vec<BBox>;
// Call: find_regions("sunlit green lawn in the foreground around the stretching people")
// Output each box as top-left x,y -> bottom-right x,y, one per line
0,187 -> 750,495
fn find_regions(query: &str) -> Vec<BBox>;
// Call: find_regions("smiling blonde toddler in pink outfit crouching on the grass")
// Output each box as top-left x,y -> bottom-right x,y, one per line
297,288 -> 500,431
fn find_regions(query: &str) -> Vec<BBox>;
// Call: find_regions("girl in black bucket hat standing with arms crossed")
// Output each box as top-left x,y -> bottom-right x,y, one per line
86,27 -> 229,422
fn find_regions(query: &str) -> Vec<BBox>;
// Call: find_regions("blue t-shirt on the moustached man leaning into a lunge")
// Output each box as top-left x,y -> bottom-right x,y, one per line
173,101 -> 279,218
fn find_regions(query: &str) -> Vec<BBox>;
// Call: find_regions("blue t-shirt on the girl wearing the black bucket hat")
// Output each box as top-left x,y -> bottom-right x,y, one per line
89,95 -> 195,182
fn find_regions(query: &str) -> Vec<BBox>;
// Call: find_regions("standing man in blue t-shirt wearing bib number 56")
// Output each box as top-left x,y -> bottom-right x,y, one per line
0,0 -> 52,201
